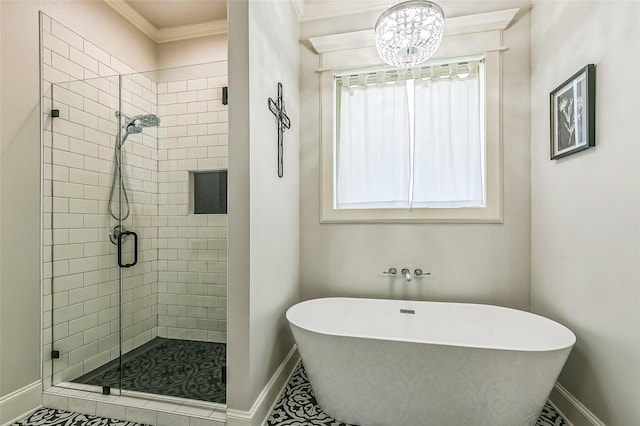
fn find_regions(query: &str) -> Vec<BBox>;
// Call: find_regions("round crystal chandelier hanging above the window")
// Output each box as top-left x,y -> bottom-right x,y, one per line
375,0 -> 444,67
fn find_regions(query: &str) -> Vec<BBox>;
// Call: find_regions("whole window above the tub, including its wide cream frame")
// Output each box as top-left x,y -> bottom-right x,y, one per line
321,52 -> 502,223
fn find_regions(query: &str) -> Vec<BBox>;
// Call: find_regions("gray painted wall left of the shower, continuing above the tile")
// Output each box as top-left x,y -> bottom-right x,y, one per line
0,1 -> 155,402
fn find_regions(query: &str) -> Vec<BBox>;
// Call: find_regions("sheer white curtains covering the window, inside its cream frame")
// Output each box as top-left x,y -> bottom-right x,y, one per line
334,58 -> 485,209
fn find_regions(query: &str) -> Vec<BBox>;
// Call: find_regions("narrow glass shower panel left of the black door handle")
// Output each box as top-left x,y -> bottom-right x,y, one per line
43,76 -> 121,392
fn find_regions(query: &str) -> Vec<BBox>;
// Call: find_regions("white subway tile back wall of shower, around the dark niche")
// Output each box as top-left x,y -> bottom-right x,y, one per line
158,77 -> 228,342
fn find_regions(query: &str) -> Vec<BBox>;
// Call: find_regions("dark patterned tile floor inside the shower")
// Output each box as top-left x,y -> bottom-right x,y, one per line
74,337 -> 227,404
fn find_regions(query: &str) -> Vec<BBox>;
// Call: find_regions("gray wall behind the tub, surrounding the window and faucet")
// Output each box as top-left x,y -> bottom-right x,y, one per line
300,9 -> 530,309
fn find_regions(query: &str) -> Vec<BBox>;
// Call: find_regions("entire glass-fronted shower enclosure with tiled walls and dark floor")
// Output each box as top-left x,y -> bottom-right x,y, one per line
43,62 -> 228,404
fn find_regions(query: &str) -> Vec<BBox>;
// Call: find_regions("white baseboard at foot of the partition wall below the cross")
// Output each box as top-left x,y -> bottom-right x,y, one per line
227,345 -> 300,426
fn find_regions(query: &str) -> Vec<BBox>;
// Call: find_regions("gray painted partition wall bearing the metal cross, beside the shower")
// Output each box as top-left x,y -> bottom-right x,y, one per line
227,1 -> 301,412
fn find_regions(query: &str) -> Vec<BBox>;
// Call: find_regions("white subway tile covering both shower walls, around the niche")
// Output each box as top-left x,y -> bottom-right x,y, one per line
42,15 -> 228,388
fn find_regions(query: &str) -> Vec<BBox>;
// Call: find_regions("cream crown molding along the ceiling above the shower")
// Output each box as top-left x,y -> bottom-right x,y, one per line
104,0 -> 227,43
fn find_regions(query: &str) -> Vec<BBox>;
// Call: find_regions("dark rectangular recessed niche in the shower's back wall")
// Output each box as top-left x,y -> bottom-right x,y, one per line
192,170 -> 227,214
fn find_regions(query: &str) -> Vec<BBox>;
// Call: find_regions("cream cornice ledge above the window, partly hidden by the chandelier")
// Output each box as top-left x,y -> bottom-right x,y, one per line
309,9 -> 520,54
